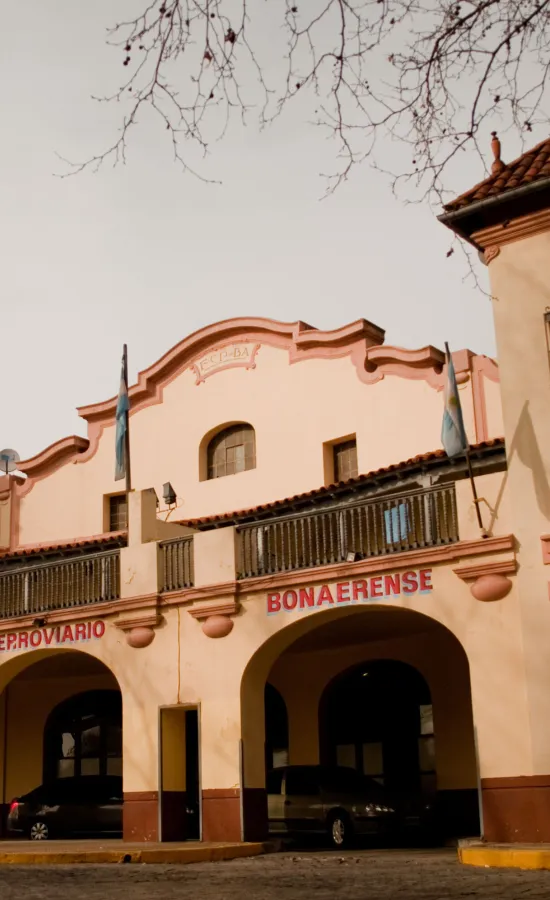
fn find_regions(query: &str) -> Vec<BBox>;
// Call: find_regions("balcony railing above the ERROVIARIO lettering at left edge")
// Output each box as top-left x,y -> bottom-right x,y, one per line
0,550 -> 120,619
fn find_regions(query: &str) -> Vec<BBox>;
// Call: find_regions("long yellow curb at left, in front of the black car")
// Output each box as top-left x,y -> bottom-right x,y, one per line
0,843 -> 266,866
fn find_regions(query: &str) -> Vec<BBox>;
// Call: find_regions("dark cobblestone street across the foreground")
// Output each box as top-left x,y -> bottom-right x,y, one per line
0,851 -> 550,900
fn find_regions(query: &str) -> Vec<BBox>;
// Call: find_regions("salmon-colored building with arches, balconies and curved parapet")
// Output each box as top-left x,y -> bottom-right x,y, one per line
0,134 -> 550,841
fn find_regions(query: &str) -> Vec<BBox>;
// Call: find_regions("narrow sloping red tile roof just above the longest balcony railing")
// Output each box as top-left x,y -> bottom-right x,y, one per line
178,438 -> 504,528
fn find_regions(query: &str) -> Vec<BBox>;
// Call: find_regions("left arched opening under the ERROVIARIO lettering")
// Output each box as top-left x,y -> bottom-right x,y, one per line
0,650 -> 123,837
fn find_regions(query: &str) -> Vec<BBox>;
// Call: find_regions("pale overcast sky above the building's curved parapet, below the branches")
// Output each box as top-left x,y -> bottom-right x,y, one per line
0,0 -> 540,459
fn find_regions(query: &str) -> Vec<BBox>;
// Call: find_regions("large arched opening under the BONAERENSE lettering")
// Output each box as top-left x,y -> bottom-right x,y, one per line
241,604 -> 480,838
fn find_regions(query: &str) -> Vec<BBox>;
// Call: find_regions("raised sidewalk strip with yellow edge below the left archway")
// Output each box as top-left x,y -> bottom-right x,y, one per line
0,841 -> 267,866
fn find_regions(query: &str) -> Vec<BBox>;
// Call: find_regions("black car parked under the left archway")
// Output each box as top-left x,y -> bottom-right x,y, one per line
8,775 -> 123,841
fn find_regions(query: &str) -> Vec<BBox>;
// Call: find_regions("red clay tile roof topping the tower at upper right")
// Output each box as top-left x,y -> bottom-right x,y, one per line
444,138 -> 550,212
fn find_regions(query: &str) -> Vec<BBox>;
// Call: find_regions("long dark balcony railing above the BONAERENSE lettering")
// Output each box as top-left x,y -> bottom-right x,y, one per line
237,485 -> 458,578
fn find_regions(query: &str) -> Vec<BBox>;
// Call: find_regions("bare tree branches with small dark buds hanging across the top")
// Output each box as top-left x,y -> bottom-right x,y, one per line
69,0 -> 550,202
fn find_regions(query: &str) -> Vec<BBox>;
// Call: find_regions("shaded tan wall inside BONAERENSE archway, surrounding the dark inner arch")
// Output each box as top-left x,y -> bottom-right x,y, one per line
241,604 -> 479,834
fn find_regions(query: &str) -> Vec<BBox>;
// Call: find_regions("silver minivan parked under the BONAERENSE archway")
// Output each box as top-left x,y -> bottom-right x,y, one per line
267,766 -> 397,848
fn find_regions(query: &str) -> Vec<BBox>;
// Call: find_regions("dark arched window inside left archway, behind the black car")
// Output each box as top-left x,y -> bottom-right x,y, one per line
44,691 -> 122,781
